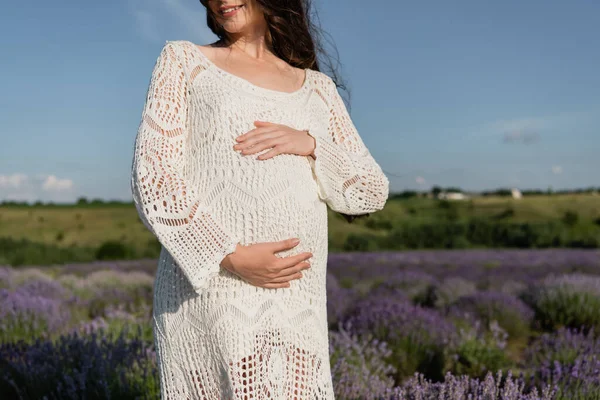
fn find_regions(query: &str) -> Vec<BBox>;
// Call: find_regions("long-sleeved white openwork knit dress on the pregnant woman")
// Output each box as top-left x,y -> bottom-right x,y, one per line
131,40 -> 388,400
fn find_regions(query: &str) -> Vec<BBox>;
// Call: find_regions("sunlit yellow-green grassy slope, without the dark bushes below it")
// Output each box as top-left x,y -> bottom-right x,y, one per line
0,194 -> 600,262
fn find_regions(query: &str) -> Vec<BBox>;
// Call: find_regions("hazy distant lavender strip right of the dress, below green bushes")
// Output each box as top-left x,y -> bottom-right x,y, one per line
328,249 -> 600,291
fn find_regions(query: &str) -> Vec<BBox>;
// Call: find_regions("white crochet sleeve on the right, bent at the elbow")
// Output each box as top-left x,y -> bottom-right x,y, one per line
308,75 -> 389,215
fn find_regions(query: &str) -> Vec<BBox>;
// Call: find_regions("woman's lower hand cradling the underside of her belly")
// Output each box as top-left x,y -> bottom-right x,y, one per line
221,239 -> 313,288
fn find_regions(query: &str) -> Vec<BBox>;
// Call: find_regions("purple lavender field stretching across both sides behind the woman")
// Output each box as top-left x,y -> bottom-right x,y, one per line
0,249 -> 600,400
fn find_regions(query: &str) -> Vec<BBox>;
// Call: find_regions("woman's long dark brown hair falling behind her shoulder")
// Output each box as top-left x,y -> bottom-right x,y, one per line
200,0 -> 369,223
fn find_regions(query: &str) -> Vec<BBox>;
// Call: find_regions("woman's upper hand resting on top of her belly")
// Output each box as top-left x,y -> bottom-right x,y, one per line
233,121 -> 316,160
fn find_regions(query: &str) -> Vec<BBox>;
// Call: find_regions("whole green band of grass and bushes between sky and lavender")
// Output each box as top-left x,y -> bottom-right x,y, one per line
0,195 -> 600,266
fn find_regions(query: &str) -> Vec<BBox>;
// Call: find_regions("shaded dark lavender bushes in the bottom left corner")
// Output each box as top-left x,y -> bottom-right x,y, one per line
0,328 -> 158,399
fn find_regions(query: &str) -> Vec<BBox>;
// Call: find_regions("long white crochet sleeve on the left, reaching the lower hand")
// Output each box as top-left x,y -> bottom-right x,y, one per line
131,41 -> 239,290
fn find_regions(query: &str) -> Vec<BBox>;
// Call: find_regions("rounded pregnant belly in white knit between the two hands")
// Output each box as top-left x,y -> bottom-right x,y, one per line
205,154 -> 327,242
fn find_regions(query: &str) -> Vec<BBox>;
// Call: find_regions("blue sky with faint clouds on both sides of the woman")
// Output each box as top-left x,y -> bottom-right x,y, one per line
0,0 -> 600,202
